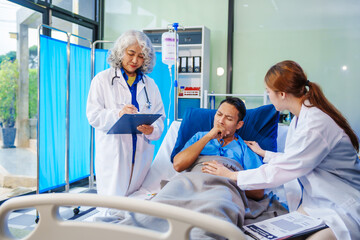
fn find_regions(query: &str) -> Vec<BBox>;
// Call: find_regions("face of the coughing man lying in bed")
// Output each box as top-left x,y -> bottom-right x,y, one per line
214,102 -> 244,137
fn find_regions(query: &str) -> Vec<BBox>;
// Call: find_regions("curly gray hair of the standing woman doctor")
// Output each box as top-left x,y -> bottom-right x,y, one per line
107,30 -> 156,73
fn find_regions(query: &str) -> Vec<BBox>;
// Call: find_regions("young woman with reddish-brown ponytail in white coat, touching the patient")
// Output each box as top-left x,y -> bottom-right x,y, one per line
203,61 -> 360,240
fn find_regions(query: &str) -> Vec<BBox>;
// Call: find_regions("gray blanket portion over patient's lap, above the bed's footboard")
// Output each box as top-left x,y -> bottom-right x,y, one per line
152,156 -> 246,226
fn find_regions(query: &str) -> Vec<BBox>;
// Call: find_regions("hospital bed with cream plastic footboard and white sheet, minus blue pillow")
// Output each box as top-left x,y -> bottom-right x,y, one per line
0,105 -> 286,240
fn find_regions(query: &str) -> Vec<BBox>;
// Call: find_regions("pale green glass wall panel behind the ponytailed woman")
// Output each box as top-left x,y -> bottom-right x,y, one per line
233,0 -> 360,135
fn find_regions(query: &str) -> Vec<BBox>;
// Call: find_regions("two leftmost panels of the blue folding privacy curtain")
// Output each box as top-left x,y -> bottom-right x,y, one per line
39,36 -> 91,193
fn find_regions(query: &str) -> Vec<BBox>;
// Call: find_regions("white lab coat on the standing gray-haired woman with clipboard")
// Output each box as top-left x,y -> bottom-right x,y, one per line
86,68 -> 165,196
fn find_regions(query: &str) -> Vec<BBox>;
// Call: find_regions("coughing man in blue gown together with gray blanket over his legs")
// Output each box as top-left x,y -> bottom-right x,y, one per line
97,98 -> 284,239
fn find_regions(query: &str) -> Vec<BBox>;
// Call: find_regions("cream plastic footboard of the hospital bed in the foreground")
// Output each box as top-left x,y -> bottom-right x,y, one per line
0,193 -> 245,240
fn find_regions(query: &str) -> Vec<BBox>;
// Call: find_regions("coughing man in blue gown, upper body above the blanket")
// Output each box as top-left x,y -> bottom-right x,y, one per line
173,97 -> 264,199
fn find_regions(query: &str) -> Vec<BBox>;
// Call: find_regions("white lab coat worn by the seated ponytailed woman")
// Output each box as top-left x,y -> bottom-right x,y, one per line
237,105 -> 360,240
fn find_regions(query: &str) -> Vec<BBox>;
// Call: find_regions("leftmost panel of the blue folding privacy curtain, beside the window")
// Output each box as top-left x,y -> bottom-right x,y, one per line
38,35 -> 67,193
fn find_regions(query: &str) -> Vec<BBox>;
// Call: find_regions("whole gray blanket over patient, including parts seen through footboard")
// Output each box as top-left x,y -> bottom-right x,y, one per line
97,156 -> 286,239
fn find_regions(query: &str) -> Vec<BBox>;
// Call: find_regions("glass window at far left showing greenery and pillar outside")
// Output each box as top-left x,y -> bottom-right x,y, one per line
0,0 -> 42,201
